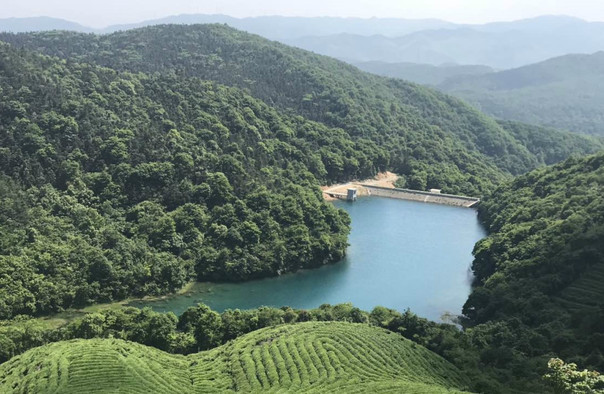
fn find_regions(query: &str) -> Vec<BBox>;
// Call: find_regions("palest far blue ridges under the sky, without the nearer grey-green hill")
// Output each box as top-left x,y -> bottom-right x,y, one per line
0,15 -> 604,69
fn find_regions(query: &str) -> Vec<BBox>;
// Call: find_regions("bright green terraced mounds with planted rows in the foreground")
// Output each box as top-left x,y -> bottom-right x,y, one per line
0,322 -> 467,393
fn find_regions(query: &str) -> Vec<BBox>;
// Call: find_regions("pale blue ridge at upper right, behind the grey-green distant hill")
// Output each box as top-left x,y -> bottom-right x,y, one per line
286,17 -> 604,70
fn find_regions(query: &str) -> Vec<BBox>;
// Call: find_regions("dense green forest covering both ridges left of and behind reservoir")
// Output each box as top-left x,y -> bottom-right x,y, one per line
0,26 -> 594,318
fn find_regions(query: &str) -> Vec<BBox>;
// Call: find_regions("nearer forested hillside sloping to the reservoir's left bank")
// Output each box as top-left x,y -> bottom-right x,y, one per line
0,44 -> 364,318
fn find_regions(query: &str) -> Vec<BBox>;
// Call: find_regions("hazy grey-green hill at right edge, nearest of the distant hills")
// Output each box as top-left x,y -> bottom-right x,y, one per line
438,52 -> 604,136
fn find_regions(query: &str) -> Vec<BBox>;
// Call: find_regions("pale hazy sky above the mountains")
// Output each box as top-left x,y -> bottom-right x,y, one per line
0,0 -> 604,27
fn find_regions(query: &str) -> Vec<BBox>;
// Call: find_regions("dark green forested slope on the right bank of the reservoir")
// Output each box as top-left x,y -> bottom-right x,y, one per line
464,153 -> 604,388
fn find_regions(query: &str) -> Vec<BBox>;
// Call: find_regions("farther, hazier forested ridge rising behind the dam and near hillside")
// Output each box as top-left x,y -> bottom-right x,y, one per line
0,25 -> 593,195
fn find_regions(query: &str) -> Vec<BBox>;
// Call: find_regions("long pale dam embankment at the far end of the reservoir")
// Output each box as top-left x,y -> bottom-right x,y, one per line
358,183 -> 480,208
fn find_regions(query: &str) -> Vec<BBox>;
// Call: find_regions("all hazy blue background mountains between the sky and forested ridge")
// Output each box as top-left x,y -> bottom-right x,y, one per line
0,15 -> 604,135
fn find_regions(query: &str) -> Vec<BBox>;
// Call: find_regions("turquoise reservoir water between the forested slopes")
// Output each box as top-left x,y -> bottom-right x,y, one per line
132,197 -> 485,320
